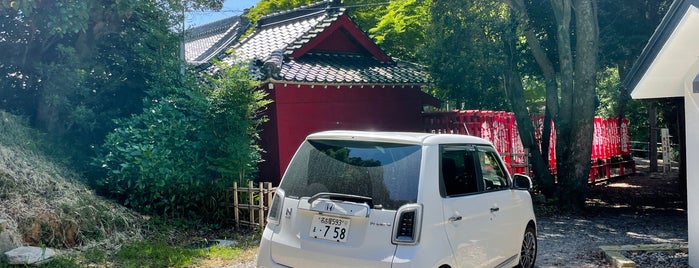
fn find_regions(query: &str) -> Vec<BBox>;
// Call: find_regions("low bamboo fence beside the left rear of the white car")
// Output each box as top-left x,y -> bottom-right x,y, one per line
228,181 -> 276,229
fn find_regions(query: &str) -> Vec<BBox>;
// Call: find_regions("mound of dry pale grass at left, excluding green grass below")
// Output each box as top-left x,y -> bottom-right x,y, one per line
0,111 -> 142,248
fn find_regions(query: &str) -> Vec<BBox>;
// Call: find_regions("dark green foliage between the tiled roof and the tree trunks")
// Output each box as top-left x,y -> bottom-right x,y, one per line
426,1 -> 510,110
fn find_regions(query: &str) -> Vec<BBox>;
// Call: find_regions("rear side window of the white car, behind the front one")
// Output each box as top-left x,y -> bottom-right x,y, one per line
440,145 -> 480,196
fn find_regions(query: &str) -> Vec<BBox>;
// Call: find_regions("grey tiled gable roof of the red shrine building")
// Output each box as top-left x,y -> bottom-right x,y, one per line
187,0 -> 427,85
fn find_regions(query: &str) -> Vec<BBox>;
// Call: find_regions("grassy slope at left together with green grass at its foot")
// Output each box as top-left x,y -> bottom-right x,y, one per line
0,111 -> 259,268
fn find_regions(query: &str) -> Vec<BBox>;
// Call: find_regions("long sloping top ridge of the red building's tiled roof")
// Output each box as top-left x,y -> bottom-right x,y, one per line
257,0 -> 345,28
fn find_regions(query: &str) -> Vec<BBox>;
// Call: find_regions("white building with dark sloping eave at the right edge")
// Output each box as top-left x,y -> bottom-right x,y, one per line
624,0 -> 699,267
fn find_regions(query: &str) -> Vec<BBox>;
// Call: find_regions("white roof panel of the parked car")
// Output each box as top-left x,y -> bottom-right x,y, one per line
307,130 -> 492,145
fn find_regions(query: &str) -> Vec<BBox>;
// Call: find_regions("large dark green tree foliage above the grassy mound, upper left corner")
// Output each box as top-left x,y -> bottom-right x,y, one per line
0,0 -> 222,172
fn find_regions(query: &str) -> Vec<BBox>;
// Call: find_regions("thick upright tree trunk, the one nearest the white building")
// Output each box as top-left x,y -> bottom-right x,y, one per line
552,0 -> 599,210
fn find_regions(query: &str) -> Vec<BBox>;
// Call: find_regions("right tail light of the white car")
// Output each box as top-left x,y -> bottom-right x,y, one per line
391,204 -> 422,245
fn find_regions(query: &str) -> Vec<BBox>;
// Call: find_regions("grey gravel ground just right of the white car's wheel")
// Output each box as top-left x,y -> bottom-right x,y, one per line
536,211 -> 687,267
